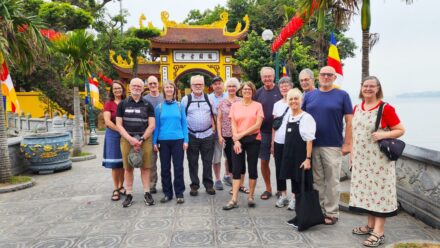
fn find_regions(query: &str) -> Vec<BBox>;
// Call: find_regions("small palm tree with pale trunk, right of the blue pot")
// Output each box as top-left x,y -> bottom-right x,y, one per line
54,29 -> 102,156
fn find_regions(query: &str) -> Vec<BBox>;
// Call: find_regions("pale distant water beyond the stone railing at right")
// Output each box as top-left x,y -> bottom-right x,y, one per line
352,97 -> 440,151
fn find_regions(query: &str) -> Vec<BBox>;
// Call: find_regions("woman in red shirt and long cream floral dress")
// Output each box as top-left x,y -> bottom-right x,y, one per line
349,76 -> 405,247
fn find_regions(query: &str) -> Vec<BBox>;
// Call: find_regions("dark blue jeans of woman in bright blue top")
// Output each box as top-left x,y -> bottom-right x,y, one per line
158,139 -> 185,199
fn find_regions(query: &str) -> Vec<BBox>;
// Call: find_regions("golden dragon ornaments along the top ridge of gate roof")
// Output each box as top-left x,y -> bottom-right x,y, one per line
160,11 -> 250,36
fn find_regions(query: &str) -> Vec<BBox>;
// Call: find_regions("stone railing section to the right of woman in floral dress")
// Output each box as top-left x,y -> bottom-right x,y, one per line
396,145 -> 440,228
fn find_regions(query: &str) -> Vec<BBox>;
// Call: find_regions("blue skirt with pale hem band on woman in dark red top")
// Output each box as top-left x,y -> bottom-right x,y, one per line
102,128 -> 123,169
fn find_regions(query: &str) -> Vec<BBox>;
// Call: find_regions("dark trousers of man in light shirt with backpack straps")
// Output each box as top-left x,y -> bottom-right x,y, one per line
186,134 -> 214,189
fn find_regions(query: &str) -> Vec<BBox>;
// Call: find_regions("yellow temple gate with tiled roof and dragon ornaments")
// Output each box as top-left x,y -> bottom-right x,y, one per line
110,11 -> 250,88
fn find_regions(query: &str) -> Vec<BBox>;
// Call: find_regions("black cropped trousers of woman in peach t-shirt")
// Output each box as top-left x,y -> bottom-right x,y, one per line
232,135 -> 261,180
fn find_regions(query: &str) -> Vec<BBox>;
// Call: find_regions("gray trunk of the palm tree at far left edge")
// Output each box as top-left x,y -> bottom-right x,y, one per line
0,98 -> 12,183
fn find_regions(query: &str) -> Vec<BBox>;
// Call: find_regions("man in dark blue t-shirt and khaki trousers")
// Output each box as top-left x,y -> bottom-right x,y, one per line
302,66 -> 353,225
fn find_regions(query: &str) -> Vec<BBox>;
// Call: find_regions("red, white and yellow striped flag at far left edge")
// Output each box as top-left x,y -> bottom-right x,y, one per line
0,56 -> 21,113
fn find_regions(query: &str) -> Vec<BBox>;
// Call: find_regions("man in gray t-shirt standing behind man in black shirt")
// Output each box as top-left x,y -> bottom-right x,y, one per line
143,76 -> 163,194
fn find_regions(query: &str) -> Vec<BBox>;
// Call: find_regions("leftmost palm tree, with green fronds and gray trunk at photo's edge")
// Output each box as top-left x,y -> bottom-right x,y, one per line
0,0 -> 46,183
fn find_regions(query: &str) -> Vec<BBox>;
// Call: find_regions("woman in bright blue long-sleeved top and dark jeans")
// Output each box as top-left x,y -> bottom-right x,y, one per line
153,81 -> 188,204
